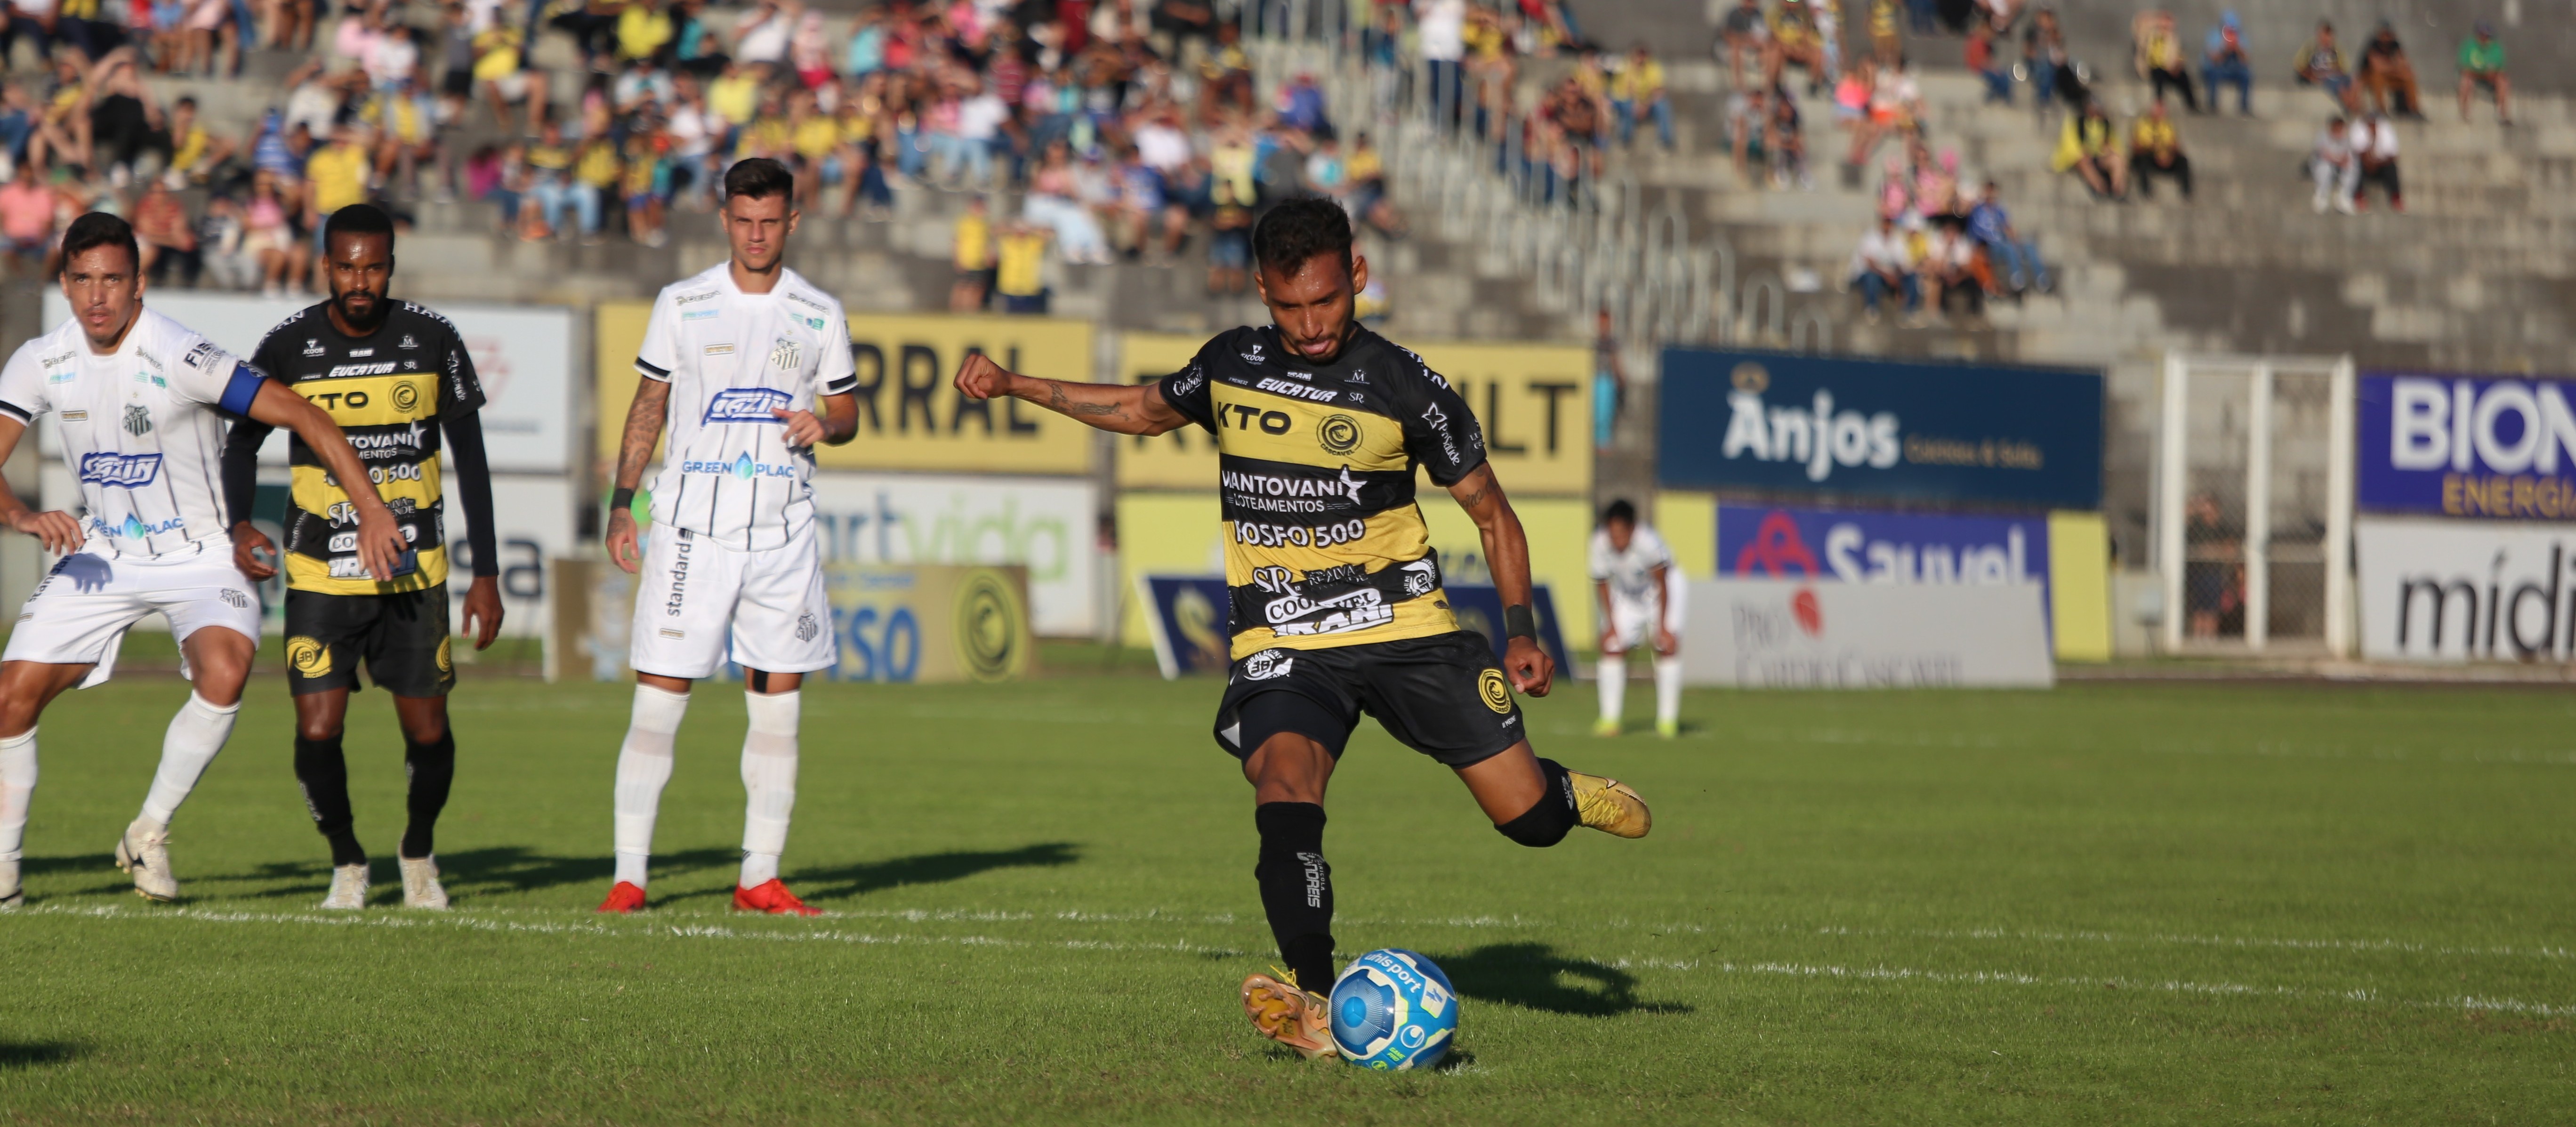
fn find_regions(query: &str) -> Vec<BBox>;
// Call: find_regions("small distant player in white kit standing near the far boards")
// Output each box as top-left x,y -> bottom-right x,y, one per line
1592,502 -> 1685,739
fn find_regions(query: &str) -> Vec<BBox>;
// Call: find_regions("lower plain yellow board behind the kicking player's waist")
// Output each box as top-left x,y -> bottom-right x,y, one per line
1118,491 -> 1597,651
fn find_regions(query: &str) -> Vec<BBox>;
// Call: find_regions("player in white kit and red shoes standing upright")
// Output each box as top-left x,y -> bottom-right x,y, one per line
600,157 -> 858,916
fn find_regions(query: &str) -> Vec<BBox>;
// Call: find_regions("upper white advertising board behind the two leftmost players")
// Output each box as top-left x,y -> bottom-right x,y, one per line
41,288 -> 577,474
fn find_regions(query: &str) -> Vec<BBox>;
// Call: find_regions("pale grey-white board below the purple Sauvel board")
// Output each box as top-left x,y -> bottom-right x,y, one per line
1682,576 -> 2056,690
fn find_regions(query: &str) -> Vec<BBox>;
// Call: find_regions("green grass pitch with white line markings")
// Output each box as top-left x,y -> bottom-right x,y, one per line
0,656 -> 2576,1125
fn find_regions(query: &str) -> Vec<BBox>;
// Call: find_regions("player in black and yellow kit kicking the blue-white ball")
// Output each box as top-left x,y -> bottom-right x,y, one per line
956,201 -> 1649,1057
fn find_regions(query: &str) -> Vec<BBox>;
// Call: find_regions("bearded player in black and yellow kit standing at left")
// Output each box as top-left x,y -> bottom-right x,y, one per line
224,203 -> 500,908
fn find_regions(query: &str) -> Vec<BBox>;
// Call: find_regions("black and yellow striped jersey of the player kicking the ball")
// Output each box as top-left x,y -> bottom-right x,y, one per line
1159,327 -> 1484,659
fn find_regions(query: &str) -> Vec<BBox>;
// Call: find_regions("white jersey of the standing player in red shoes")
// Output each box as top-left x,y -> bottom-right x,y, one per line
636,265 -> 858,551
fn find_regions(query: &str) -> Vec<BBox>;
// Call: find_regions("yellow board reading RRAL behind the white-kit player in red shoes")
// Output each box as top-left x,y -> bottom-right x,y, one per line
593,301 -> 1103,481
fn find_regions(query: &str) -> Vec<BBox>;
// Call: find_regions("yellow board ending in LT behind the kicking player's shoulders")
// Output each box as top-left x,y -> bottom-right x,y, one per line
1118,332 -> 1592,494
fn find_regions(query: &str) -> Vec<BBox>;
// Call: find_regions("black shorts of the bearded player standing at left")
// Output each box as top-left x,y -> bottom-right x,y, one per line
286,587 -> 456,697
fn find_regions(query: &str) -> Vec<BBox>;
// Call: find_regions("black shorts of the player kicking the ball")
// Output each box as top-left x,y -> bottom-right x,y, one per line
1216,630 -> 1528,767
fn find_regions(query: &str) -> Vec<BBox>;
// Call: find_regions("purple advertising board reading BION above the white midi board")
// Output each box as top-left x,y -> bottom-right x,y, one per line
2354,373 -> 2576,520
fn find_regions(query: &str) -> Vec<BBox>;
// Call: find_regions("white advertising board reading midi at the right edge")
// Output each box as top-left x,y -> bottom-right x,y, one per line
2352,517 -> 2576,661
